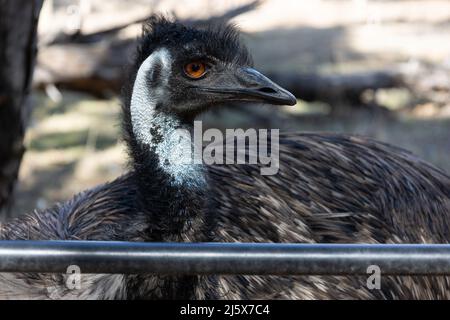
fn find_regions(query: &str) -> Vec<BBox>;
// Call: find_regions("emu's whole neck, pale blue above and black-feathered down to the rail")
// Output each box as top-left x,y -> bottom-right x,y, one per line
130,49 -> 207,241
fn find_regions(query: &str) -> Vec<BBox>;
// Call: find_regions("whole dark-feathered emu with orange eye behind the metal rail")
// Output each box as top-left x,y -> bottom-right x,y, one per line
0,16 -> 450,299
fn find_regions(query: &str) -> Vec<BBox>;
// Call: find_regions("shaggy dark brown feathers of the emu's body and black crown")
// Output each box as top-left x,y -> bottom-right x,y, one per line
0,18 -> 450,299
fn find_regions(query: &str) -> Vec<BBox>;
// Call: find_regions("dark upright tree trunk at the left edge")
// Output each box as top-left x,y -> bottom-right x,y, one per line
0,0 -> 42,218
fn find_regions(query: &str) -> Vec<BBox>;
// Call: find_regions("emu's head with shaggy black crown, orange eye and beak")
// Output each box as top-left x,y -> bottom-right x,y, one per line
125,16 -> 296,122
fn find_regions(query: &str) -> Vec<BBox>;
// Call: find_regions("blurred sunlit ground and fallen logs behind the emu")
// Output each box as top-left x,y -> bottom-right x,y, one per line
0,0 -> 450,216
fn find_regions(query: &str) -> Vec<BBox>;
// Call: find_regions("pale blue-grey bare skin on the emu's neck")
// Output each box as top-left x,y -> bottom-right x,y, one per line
130,48 -> 205,188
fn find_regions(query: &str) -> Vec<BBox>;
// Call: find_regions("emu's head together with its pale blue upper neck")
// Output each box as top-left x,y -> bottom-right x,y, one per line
119,16 -> 296,187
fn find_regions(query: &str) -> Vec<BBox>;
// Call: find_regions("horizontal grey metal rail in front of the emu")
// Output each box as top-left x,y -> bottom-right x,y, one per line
0,241 -> 450,275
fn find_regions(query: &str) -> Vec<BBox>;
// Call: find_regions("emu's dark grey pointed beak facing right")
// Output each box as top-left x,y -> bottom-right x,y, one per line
204,68 -> 297,106
